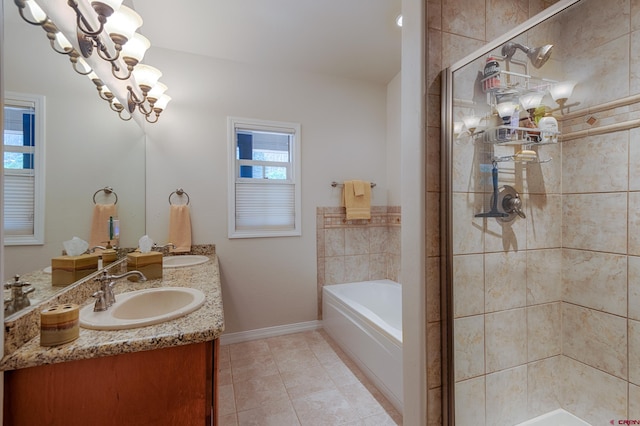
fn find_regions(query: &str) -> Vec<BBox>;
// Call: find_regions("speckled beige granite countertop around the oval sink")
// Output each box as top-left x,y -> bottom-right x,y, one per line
0,254 -> 224,371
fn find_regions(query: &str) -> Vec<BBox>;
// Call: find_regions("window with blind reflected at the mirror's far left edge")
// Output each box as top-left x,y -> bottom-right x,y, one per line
3,92 -> 44,245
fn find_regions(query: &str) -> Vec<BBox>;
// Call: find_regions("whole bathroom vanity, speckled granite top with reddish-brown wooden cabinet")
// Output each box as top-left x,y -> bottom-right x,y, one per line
0,250 -> 224,426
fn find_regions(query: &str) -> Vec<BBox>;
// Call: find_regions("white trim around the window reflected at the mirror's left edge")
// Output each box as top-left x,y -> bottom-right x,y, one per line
3,91 -> 45,246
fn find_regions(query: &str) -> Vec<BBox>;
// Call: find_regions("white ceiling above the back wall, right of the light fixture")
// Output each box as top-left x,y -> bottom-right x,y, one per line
130,0 -> 401,83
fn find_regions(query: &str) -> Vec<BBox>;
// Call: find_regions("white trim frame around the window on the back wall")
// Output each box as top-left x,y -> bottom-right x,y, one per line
227,117 -> 302,239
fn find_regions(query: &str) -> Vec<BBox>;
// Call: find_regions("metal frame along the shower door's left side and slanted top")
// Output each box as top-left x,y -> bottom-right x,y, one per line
440,0 -> 582,426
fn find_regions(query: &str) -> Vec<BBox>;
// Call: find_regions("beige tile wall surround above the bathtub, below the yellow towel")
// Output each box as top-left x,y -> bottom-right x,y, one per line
316,206 -> 401,312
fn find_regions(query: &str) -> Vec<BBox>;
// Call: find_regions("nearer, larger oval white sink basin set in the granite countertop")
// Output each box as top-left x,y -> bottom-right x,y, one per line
80,287 -> 205,330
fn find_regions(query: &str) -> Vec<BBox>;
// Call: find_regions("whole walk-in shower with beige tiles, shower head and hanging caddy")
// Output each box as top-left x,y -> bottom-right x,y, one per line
442,0 -> 640,426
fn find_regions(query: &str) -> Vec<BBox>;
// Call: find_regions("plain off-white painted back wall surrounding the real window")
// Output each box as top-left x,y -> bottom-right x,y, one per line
146,48 -> 396,333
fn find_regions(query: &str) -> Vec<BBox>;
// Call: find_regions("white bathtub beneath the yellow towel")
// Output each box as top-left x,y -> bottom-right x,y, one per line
322,280 -> 402,412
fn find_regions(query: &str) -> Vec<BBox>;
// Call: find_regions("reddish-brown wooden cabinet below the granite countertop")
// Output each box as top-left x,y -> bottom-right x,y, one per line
4,339 -> 219,426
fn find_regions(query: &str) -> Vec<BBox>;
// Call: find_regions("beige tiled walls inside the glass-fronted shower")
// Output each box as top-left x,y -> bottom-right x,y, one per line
453,0 -> 640,425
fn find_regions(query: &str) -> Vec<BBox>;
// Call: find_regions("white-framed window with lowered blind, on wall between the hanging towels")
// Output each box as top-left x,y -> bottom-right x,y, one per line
228,118 -> 301,238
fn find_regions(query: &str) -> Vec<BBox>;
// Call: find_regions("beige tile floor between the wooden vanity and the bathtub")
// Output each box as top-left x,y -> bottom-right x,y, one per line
218,330 -> 402,426
